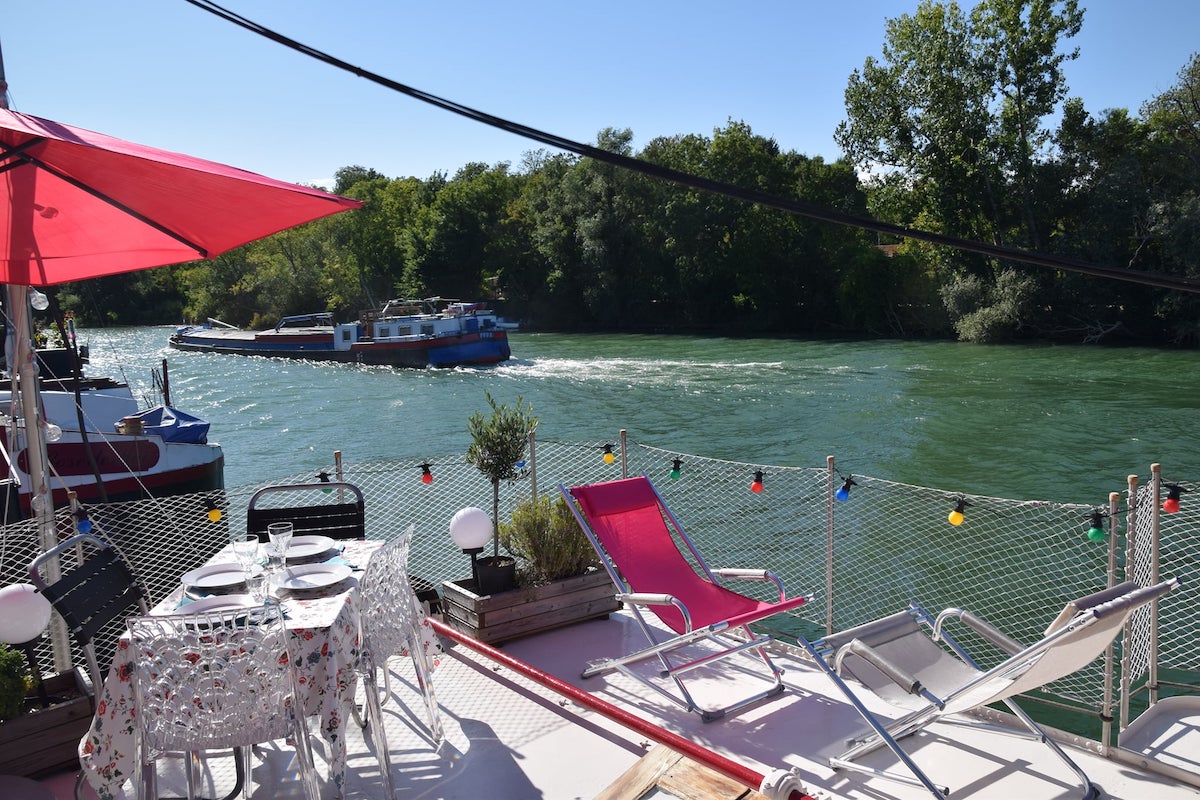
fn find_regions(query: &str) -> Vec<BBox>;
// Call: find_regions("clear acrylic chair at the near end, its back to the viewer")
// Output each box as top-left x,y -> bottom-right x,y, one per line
130,603 -> 320,800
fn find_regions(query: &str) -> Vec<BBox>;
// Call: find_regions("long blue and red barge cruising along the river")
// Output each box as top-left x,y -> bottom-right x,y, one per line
170,297 -> 511,367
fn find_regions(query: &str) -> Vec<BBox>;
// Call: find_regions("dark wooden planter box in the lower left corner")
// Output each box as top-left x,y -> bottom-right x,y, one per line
0,669 -> 94,777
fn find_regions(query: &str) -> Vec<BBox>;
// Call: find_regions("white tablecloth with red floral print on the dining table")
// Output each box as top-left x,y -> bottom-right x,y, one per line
79,540 -> 442,800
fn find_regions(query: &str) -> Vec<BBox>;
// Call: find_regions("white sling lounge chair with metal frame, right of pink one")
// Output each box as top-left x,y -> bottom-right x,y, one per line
800,578 -> 1180,800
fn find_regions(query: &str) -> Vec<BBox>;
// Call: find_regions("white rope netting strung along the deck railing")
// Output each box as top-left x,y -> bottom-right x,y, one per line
0,435 -> 1200,738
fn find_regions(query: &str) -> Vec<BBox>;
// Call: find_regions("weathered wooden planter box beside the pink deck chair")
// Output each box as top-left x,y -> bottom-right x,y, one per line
442,570 -> 620,644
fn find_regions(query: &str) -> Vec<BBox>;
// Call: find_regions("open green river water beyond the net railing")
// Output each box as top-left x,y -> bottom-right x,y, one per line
87,327 -> 1200,504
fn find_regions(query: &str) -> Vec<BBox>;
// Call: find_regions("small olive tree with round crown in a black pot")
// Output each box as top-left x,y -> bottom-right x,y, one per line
467,390 -> 538,595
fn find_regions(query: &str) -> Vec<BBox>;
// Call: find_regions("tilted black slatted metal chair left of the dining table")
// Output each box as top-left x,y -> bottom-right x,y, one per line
29,534 -> 149,691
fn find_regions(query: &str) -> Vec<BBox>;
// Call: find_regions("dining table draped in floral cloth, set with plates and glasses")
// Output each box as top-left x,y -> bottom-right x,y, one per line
79,539 -> 443,800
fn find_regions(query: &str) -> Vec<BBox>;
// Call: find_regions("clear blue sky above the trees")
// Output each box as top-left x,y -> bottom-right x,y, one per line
0,0 -> 1200,184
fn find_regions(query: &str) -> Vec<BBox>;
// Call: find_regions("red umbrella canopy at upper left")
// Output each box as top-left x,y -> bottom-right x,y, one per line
0,108 -> 361,285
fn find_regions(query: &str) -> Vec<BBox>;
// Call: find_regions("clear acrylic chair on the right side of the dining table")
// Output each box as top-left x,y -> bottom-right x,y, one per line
359,525 -> 444,796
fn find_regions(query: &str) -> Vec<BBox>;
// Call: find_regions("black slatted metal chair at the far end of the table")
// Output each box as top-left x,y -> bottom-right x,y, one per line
246,481 -> 366,542
